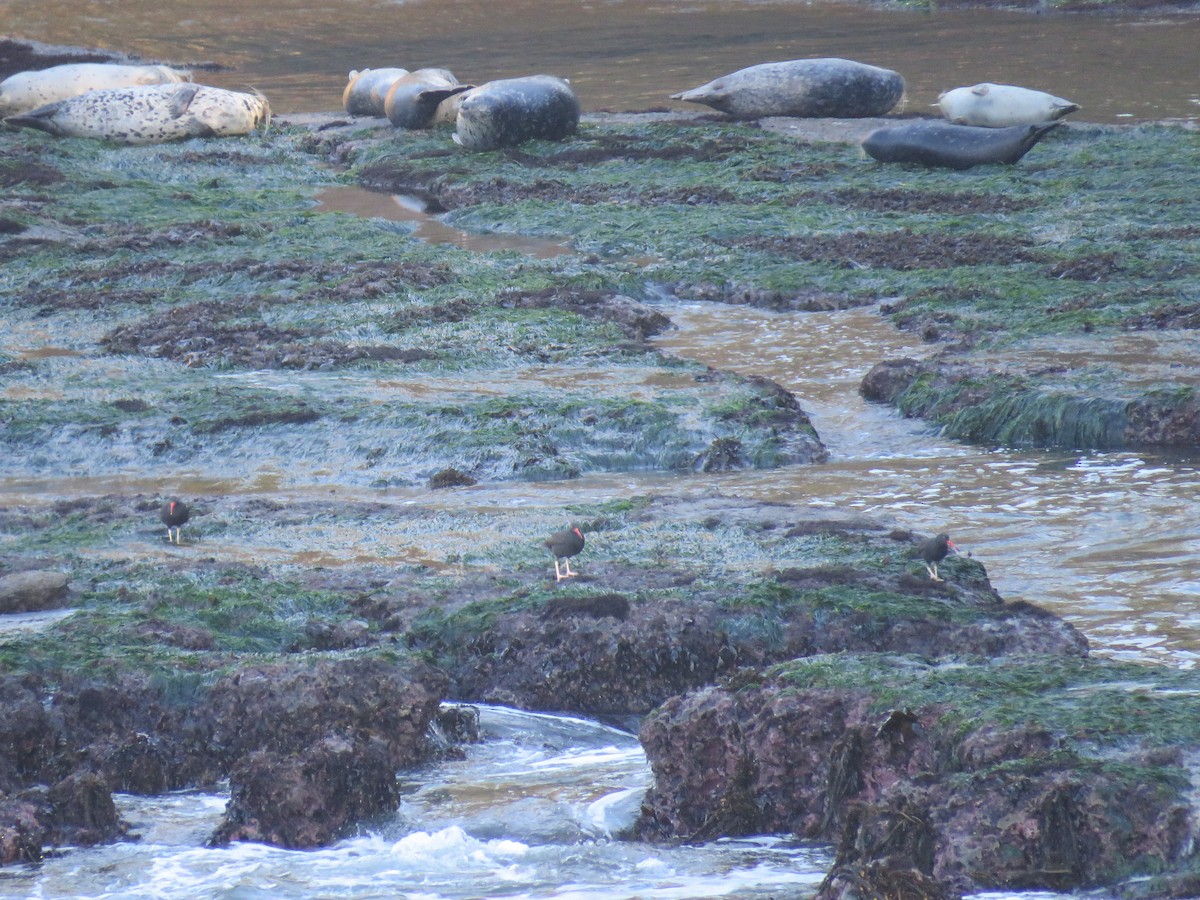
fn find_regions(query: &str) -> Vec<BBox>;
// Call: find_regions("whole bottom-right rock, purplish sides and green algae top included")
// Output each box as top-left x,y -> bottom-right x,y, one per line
638,655 -> 1200,898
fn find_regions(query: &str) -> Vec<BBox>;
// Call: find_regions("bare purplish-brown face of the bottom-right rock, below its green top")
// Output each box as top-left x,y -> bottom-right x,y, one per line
638,656 -> 1193,898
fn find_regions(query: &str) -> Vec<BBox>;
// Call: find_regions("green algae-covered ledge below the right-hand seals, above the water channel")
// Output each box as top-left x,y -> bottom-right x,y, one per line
350,116 -> 1198,369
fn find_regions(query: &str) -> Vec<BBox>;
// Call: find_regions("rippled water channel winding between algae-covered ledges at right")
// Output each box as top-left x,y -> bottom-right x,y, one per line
661,305 -> 1200,667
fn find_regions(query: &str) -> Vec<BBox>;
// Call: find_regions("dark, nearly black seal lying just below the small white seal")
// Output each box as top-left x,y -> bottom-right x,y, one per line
863,120 -> 1062,169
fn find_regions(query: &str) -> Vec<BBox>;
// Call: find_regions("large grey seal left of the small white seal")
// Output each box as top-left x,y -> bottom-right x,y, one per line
671,58 -> 904,119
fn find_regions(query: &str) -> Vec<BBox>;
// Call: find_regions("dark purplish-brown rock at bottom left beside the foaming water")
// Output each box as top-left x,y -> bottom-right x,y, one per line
0,658 -> 446,863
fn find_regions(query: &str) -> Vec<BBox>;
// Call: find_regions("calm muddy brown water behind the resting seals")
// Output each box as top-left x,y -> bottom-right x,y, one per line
7,0 -> 1200,122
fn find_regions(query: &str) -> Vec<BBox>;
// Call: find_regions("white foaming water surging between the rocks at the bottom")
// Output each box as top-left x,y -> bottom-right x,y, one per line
0,707 -> 832,900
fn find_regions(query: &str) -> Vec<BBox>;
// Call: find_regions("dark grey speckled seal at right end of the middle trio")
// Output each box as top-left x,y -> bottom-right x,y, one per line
454,74 -> 580,150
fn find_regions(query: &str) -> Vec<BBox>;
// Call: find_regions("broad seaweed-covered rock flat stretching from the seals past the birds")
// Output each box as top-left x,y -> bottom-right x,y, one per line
0,103 -> 1200,887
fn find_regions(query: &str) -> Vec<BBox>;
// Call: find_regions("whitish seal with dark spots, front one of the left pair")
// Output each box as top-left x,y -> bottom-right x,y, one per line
5,84 -> 271,144
